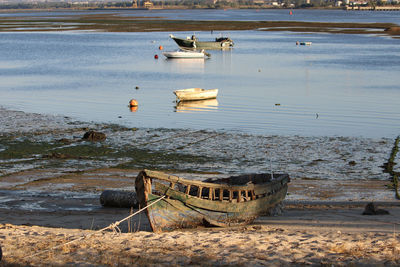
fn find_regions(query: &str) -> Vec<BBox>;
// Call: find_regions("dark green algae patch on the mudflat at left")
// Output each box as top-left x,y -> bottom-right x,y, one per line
0,133 -> 213,176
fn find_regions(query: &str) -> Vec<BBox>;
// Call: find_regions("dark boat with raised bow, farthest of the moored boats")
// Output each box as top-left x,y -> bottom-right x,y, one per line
169,34 -> 233,49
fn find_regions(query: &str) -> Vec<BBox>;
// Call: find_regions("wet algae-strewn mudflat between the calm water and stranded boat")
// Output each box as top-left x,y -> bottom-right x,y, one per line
0,109 -> 398,203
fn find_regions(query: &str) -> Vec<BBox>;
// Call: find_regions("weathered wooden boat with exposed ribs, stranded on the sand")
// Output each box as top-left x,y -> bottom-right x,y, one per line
135,170 -> 289,232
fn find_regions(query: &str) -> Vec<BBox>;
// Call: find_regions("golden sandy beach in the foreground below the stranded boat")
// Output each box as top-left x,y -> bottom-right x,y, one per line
0,205 -> 400,266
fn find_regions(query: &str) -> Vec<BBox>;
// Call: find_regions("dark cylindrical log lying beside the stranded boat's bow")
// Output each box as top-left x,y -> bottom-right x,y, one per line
100,190 -> 139,208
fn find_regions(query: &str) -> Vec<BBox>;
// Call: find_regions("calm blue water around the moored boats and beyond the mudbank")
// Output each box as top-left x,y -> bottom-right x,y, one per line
0,10 -> 400,137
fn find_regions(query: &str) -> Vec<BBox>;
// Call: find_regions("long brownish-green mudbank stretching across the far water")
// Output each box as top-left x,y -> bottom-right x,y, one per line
0,9 -> 400,37
